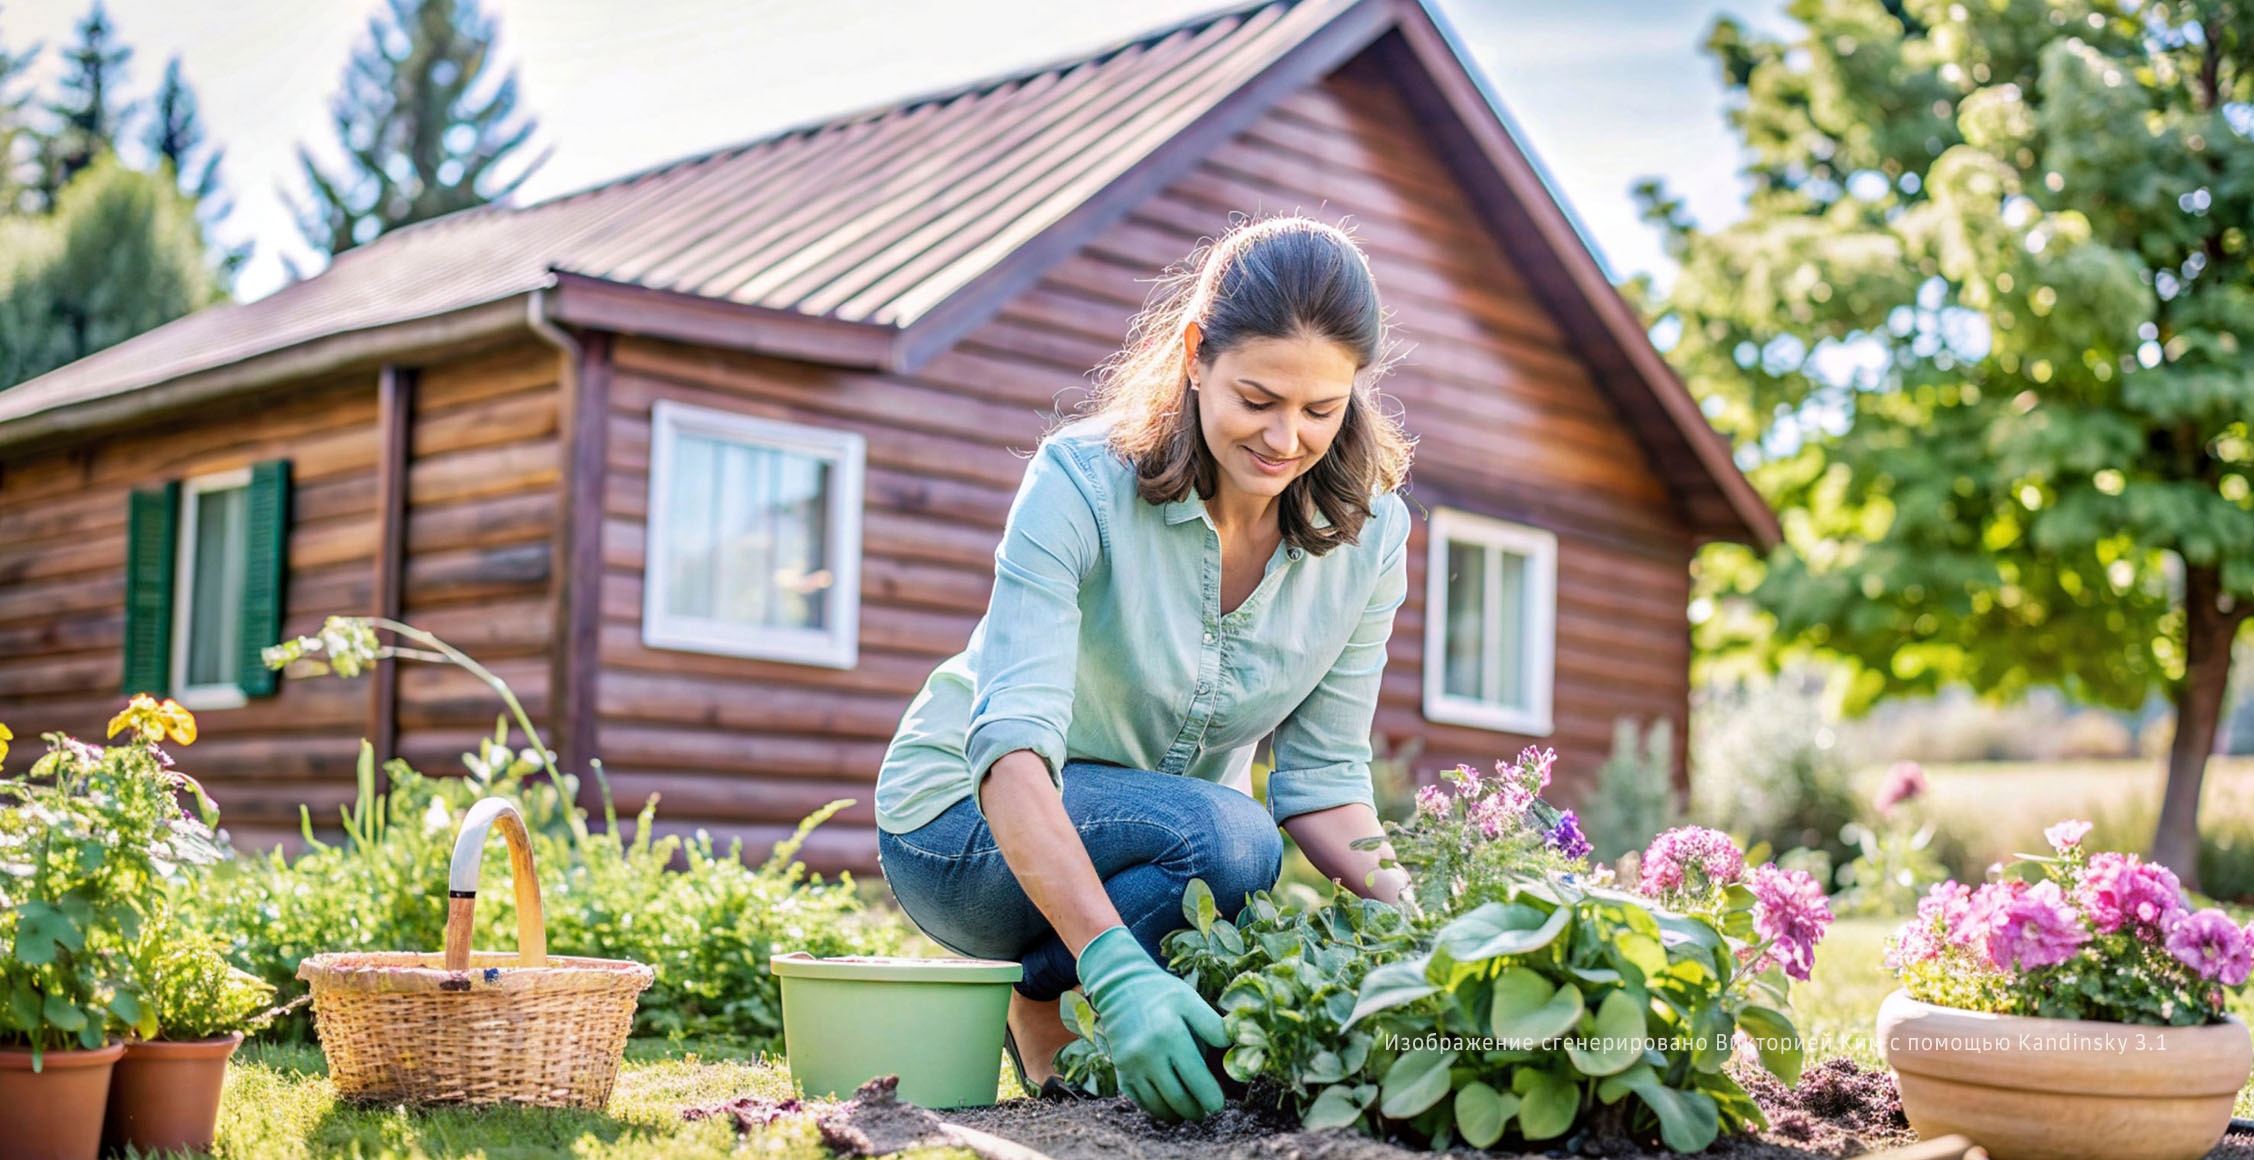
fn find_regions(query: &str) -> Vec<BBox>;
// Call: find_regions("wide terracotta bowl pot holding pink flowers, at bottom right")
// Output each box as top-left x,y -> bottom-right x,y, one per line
1878,991 -> 2254,1160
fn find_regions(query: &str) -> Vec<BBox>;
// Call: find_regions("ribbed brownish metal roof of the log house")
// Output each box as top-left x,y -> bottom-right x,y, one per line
0,0 -> 1357,423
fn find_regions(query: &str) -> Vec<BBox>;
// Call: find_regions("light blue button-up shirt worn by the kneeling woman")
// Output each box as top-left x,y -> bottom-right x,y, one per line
877,419 -> 1409,833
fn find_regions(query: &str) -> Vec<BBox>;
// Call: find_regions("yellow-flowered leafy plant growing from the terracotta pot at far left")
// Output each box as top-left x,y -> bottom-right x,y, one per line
0,694 -> 219,1068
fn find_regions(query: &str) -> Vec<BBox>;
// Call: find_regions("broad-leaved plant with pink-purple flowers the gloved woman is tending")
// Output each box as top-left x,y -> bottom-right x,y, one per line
1059,750 -> 1830,1151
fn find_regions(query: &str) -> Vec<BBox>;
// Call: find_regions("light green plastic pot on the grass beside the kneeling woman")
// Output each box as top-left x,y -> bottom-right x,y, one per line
766,951 -> 1026,1108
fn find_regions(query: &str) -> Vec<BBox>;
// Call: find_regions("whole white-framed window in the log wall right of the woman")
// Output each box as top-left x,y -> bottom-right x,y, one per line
1425,507 -> 1558,737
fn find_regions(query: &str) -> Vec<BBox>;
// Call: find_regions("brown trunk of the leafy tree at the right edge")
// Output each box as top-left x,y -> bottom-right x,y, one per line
2153,565 -> 2254,890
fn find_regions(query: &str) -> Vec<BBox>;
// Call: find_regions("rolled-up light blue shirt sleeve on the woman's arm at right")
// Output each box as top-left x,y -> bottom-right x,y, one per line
1269,496 -> 1409,822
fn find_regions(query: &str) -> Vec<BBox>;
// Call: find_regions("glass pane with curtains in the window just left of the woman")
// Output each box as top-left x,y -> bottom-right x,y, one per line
665,425 -> 832,628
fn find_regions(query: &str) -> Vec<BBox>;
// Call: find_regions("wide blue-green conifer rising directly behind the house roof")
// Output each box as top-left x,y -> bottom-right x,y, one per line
291,0 -> 545,257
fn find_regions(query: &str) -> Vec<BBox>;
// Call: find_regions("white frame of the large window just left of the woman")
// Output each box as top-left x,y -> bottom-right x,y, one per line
642,399 -> 868,669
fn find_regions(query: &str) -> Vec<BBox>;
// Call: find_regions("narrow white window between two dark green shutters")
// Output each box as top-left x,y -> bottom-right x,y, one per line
171,466 -> 250,710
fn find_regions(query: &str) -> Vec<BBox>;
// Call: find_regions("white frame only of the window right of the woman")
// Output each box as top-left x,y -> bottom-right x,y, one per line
1425,507 -> 1558,737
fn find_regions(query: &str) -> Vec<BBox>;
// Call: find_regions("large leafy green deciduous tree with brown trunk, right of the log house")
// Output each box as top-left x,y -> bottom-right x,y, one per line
1632,0 -> 2254,887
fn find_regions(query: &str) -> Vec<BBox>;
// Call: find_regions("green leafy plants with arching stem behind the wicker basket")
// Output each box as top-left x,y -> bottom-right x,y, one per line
192,617 -> 904,1045
